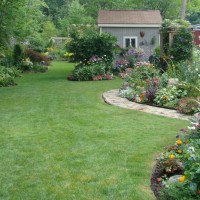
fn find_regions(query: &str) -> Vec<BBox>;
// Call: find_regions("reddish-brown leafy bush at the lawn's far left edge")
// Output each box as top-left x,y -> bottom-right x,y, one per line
25,49 -> 51,66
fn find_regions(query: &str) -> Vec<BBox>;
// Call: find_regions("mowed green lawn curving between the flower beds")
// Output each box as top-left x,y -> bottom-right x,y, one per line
0,62 -> 188,200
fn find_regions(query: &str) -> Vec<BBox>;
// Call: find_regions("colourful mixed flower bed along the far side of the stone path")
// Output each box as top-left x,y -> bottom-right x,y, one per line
119,47 -> 200,115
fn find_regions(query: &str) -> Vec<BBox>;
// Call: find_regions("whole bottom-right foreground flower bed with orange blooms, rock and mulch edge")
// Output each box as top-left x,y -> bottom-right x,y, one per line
151,113 -> 200,200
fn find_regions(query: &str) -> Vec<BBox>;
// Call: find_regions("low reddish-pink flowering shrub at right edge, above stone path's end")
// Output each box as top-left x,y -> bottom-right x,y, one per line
177,97 -> 199,114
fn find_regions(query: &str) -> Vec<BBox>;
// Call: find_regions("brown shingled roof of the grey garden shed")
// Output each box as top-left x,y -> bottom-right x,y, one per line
98,10 -> 162,25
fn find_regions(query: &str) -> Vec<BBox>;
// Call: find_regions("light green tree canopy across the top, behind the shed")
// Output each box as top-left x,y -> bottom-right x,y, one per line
0,0 -> 200,48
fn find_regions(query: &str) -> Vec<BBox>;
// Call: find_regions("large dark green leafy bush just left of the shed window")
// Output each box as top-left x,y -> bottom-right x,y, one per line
67,32 -> 116,62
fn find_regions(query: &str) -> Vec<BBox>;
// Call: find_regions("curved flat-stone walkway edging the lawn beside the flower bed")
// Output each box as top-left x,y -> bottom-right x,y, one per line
103,90 -> 191,120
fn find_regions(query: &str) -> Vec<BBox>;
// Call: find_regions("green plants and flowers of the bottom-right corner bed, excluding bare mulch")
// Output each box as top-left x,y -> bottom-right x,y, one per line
159,113 -> 200,200
